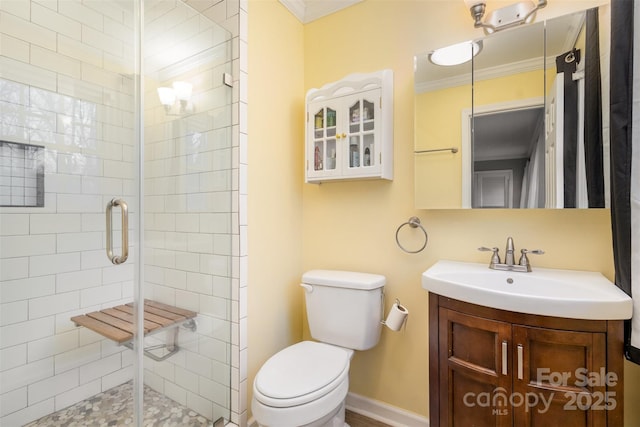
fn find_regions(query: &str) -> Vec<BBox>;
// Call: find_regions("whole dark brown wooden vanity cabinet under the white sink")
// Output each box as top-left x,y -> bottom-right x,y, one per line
429,293 -> 623,427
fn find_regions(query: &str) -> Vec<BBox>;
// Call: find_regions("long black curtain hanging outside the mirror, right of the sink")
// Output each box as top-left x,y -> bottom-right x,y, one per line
610,0 -> 640,364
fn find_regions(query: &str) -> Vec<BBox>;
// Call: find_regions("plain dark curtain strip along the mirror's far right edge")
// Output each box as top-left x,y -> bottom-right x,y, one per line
584,8 -> 604,208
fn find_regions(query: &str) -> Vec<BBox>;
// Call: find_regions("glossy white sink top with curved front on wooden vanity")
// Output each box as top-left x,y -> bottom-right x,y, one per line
422,261 -> 632,320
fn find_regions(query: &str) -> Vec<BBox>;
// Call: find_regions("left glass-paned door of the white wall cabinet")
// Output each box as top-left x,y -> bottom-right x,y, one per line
306,101 -> 342,178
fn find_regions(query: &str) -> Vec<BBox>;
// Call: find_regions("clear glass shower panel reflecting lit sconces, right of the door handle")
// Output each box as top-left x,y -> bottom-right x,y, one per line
142,1 -> 233,425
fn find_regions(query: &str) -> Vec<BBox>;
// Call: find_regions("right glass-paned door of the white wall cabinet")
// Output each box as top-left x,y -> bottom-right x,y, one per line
339,89 -> 382,176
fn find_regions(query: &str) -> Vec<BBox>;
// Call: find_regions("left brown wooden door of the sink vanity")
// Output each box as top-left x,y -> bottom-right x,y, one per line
438,308 -> 512,427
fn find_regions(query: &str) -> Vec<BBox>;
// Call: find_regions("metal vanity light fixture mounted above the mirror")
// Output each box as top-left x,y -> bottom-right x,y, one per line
464,0 -> 547,34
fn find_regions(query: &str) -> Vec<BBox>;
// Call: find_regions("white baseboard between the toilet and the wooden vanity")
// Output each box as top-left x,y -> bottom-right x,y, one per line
347,393 -> 429,427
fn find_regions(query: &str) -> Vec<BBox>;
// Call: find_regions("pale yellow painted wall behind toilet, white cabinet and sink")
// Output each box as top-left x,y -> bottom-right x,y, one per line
248,0 -> 640,425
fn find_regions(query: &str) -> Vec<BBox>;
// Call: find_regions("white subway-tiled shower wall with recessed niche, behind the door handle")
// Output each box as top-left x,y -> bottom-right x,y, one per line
0,0 -> 137,426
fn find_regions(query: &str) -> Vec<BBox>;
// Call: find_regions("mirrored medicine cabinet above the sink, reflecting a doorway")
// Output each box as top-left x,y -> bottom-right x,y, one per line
414,6 -> 610,209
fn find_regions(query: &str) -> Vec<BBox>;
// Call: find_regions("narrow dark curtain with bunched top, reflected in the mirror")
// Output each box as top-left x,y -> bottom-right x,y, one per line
556,49 -> 580,208
